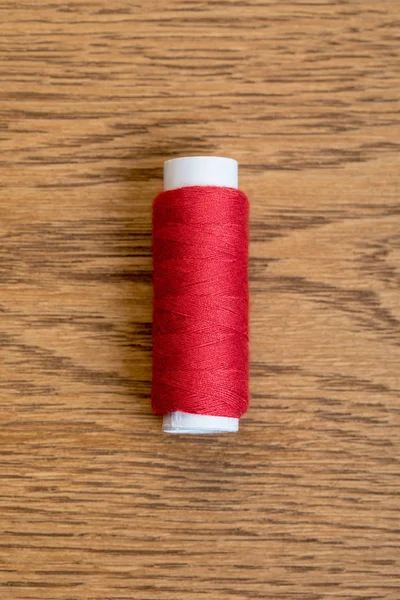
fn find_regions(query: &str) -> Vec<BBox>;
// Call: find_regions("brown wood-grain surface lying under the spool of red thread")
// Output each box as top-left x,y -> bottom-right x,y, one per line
0,0 -> 400,600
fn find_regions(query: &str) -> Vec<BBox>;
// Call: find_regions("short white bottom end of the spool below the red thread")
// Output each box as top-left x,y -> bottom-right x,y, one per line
163,411 -> 239,433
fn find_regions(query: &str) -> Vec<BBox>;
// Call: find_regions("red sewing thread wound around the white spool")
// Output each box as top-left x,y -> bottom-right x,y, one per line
152,186 -> 249,418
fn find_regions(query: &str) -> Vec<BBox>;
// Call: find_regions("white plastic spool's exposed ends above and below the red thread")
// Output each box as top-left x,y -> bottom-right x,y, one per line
163,156 -> 239,434
